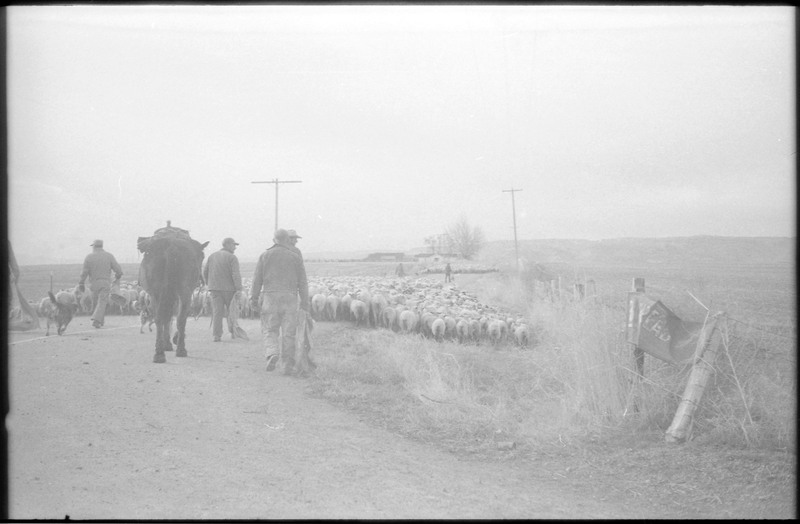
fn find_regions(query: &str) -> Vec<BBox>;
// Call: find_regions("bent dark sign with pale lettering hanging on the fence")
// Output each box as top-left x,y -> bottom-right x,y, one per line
626,292 -> 703,364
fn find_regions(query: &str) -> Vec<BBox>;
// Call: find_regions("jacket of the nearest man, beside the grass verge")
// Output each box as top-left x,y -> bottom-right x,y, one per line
251,244 -> 308,304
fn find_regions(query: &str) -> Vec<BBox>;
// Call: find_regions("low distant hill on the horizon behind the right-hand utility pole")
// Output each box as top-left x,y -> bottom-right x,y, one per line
476,236 -> 796,267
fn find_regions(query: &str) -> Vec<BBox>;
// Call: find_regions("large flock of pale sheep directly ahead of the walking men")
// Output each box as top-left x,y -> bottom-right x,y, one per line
38,276 -> 531,347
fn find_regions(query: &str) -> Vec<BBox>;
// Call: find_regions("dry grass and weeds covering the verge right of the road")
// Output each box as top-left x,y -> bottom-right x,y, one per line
304,262 -> 797,518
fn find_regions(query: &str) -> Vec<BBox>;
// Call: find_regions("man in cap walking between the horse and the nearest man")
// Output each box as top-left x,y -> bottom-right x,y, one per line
203,237 -> 242,342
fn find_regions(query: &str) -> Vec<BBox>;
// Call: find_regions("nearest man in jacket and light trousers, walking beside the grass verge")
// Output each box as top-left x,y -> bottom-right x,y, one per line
250,229 -> 309,375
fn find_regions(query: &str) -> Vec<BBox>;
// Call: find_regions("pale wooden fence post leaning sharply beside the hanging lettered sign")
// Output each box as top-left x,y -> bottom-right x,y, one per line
665,312 -> 725,443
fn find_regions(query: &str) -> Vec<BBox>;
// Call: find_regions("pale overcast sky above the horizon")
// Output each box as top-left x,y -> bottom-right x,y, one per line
7,4 -> 796,264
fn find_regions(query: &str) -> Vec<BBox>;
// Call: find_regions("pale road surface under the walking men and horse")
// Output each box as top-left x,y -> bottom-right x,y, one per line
7,317 -> 788,520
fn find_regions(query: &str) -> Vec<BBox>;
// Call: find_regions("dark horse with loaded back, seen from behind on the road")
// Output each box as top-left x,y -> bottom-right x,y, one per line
138,222 -> 208,363
